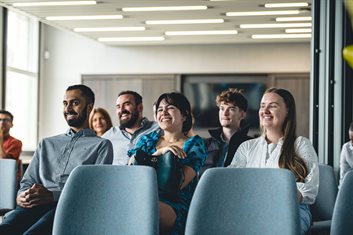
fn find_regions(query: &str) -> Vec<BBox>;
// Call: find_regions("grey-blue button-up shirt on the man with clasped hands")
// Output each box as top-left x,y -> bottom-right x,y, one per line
18,129 -> 113,201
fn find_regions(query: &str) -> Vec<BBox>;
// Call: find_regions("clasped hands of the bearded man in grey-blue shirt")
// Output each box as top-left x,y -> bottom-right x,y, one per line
16,184 -> 54,208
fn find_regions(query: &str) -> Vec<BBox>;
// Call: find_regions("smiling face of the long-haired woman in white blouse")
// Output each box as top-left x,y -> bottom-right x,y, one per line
259,92 -> 288,131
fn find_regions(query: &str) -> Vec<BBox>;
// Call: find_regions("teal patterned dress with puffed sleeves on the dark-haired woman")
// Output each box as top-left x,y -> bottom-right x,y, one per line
128,130 -> 207,234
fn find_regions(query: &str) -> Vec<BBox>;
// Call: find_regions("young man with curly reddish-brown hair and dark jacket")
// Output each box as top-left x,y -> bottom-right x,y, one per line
200,88 -> 251,175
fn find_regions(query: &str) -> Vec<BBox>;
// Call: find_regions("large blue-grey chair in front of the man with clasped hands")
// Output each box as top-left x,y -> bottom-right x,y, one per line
53,165 -> 159,235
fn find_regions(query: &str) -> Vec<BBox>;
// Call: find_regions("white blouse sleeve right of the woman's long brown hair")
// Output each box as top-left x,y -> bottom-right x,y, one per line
297,137 -> 319,204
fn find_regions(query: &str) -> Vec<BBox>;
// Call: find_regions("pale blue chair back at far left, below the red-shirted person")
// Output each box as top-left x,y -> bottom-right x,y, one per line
0,159 -> 17,212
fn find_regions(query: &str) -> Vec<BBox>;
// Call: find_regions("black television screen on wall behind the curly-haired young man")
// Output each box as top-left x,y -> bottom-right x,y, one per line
183,76 -> 266,128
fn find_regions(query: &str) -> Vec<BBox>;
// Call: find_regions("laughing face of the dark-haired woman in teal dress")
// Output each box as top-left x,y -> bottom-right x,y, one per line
156,99 -> 185,132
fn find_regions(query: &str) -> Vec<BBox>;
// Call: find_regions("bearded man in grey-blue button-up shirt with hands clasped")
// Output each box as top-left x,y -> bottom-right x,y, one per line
0,85 -> 113,235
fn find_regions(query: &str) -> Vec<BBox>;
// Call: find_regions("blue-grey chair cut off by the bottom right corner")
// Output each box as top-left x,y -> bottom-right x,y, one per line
331,171 -> 353,235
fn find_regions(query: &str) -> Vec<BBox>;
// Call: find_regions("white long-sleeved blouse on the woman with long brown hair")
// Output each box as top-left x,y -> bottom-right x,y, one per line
229,136 -> 319,204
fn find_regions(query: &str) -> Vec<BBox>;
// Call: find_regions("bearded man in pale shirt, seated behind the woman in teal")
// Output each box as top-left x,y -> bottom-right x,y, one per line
102,91 -> 158,165
